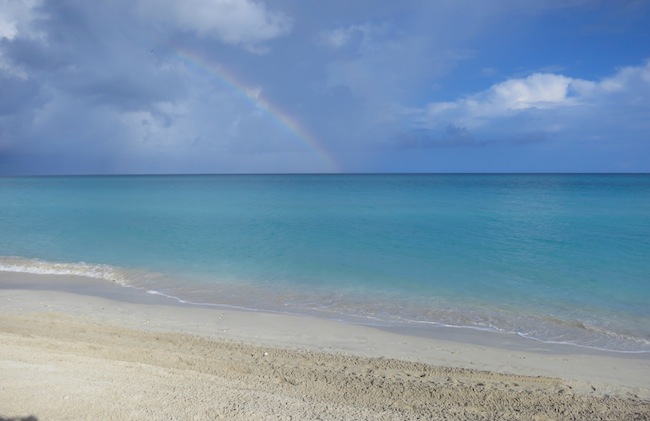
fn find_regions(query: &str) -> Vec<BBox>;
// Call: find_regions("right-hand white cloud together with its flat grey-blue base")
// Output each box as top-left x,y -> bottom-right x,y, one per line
388,60 -> 650,154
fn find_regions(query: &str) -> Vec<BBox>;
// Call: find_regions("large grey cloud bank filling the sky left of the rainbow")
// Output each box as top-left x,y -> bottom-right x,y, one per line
0,0 -> 329,174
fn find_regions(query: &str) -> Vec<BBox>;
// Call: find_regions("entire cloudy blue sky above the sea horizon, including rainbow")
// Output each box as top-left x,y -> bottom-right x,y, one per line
0,0 -> 650,175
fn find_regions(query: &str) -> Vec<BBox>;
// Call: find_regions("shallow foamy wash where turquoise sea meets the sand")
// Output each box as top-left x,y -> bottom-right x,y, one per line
0,253 -> 650,354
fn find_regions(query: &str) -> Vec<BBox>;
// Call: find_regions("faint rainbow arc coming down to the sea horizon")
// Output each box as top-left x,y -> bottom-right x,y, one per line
174,48 -> 341,173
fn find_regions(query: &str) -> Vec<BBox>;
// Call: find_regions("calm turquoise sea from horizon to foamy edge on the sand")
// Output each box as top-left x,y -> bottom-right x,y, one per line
0,175 -> 650,352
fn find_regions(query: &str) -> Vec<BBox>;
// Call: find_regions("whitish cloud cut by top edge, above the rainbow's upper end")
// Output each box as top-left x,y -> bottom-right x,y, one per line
139,0 -> 291,48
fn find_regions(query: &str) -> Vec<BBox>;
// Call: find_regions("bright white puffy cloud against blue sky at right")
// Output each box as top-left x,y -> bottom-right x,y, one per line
402,60 -> 650,144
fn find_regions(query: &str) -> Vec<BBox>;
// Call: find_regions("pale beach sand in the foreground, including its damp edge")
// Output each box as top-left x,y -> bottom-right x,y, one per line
0,272 -> 650,421
